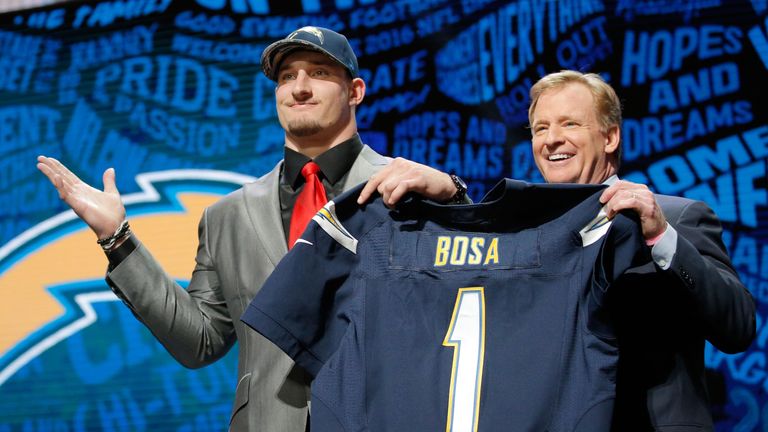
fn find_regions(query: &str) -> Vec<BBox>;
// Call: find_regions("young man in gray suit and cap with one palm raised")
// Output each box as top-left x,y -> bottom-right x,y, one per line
38,27 -> 456,432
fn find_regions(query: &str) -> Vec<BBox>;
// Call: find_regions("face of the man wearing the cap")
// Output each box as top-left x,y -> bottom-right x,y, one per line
275,51 -> 356,138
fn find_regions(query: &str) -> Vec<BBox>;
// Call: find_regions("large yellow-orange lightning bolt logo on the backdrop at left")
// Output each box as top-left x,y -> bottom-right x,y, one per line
0,170 -> 254,386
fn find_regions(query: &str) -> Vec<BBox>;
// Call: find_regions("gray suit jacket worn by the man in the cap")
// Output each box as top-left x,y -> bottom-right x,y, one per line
107,146 -> 388,432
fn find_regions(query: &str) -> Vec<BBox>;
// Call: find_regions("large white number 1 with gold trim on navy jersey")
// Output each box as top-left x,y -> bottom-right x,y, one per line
443,287 -> 485,432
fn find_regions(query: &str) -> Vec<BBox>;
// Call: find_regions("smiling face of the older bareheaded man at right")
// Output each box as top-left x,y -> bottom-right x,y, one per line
531,83 -> 619,184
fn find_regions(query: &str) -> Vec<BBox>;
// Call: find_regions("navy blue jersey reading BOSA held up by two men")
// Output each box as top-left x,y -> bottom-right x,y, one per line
242,180 -> 647,432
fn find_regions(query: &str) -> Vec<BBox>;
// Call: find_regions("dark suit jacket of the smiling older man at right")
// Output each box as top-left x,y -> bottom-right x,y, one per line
608,195 -> 755,432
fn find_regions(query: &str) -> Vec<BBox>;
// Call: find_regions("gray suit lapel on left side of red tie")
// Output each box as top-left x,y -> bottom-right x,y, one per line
243,162 -> 288,266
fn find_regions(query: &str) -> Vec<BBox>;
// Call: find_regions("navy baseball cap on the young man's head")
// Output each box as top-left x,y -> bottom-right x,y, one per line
261,26 -> 360,81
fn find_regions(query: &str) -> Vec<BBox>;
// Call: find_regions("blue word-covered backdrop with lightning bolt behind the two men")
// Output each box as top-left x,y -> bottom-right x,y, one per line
0,0 -> 768,432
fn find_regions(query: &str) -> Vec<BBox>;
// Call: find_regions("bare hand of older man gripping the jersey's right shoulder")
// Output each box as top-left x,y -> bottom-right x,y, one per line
600,180 -> 667,240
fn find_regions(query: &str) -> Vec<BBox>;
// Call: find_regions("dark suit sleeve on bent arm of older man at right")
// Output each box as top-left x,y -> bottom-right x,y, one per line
666,201 -> 755,353
